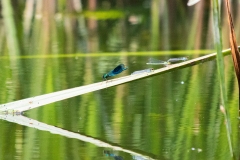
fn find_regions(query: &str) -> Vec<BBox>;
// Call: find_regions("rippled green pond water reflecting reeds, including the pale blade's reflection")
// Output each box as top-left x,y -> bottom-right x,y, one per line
0,1 -> 240,160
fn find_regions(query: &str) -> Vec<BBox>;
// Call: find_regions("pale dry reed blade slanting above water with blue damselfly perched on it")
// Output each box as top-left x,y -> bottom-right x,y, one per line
0,49 -> 235,115
